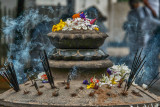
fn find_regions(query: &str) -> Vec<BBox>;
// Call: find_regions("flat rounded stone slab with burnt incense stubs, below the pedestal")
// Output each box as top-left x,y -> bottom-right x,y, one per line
0,81 -> 160,107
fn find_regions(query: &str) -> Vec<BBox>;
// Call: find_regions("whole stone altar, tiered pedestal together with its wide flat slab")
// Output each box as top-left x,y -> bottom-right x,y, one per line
0,30 -> 160,107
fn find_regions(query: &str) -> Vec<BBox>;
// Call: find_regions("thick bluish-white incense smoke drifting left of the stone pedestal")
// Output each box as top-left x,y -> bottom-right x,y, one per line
2,9 -> 57,83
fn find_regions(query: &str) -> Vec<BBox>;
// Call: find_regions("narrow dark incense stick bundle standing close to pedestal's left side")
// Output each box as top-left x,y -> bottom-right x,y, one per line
40,50 -> 55,88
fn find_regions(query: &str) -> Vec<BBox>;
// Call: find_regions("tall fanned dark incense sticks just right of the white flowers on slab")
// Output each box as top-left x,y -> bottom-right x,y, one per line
124,48 -> 146,93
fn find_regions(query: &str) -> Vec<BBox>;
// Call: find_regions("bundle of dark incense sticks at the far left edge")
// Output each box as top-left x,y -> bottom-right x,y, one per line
0,63 -> 20,92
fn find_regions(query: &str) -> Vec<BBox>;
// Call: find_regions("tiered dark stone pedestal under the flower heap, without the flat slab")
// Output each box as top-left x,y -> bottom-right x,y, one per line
48,30 -> 112,79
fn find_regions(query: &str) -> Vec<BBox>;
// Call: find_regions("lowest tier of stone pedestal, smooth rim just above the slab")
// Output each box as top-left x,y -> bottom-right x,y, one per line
49,59 -> 113,80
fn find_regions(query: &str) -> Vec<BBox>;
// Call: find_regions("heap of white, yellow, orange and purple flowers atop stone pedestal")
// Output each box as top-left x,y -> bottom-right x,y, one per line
52,12 -> 99,32
